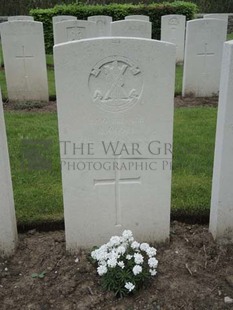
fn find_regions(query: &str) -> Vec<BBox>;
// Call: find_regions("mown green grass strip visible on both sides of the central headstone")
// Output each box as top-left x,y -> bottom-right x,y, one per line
5,108 -> 216,224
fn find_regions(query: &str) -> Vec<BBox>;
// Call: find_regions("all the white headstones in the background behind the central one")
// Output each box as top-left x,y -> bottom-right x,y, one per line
0,14 -> 230,102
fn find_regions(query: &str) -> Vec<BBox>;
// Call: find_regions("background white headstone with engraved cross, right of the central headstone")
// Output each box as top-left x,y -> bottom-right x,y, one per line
182,19 -> 227,97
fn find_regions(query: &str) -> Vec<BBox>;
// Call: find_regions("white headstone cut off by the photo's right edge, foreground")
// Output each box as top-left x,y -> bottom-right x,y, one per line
209,41 -> 233,243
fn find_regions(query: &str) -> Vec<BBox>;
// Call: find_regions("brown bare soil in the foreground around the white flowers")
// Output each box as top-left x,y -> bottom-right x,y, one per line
0,222 -> 233,310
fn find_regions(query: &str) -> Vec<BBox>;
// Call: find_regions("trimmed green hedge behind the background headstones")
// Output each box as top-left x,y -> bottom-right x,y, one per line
30,1 -> 197,54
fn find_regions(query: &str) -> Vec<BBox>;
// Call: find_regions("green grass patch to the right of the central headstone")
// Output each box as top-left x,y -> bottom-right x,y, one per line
172,108 -> 217,215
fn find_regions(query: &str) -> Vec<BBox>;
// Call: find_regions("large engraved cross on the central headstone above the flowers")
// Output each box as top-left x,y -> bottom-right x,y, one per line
94,159 -> 141,226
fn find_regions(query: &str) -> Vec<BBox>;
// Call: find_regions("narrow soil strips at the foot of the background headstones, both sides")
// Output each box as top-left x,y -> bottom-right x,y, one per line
4,96 -> 218,112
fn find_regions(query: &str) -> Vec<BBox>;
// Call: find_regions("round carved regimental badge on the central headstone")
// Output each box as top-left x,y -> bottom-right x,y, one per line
89,56 -> 143,112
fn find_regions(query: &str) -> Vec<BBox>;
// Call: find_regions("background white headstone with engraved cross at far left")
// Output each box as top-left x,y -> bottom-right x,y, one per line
0,21 -> 48,102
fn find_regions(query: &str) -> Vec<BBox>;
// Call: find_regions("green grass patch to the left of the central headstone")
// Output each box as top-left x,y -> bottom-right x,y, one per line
5,112 -> 63,224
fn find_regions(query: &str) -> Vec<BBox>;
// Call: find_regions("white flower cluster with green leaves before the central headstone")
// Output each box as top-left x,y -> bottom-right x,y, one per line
91,230 -> 158,296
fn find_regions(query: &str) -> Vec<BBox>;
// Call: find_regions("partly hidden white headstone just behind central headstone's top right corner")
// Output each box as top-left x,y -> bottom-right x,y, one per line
161,15 -> 186,62
